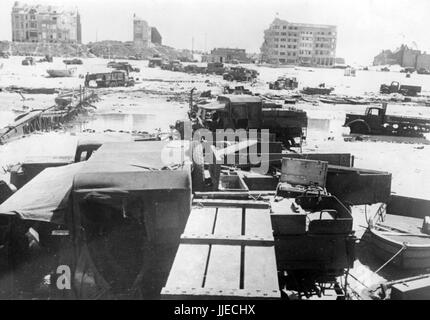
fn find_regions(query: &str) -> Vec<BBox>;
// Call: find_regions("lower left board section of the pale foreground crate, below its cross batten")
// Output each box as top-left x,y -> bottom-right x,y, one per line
166,244 -> 209,288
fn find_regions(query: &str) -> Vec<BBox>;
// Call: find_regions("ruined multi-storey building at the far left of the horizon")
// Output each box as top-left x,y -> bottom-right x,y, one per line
11,1 -> 82,43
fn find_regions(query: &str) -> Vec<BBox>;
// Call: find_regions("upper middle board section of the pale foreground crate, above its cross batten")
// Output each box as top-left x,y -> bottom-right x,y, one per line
214,208 -> 242,235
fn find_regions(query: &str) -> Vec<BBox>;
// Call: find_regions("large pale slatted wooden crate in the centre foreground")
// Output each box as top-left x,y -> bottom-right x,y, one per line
161,207 -> 280,299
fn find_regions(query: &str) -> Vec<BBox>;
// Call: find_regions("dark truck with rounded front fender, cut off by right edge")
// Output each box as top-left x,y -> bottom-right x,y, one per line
344,103 -> 430,138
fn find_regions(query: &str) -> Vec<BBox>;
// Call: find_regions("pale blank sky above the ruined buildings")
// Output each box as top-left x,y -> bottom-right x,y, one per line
0,0 -> 430,64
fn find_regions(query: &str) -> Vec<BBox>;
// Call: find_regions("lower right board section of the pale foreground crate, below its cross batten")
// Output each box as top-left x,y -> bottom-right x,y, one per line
244,246 -> 279,293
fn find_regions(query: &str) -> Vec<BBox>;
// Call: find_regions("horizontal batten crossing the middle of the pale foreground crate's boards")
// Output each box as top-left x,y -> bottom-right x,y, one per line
181,233 -> 275,246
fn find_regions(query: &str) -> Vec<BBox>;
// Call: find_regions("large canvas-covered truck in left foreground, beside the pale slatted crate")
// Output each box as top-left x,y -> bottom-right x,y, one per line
0,141 -> 192,299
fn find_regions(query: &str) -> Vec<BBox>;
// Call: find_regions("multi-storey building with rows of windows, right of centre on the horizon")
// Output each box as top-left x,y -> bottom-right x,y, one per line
261,18 -> 337,67
